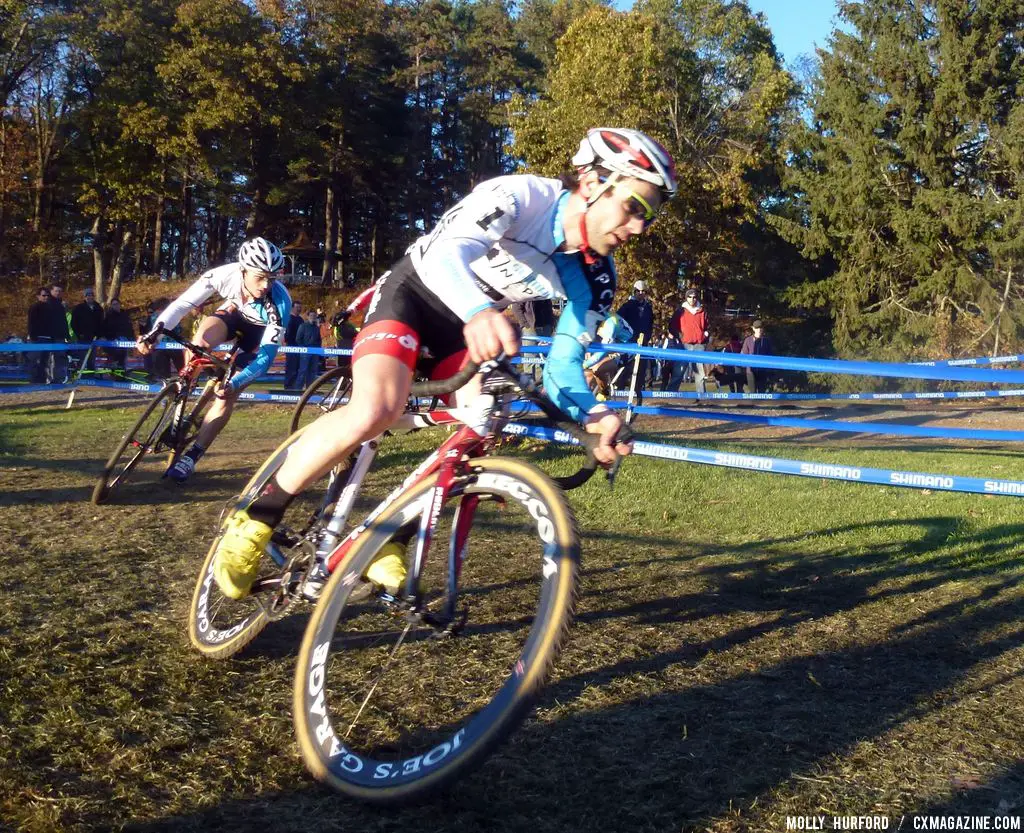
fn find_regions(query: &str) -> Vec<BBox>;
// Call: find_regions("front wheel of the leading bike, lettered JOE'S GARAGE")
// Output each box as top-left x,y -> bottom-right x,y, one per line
294,457 -> 580,803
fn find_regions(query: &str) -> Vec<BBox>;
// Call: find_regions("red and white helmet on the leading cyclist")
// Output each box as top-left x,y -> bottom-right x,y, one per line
572,127 -> 678,199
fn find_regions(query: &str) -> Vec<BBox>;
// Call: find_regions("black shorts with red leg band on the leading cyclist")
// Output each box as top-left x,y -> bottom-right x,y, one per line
352,255 -> 466,379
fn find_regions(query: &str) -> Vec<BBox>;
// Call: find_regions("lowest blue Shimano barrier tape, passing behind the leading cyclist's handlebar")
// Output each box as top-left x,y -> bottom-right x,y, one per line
505,422 -> 1024,497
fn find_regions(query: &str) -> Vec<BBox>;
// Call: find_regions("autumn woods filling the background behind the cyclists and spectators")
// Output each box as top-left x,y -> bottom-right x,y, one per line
0,0 -> 1024,358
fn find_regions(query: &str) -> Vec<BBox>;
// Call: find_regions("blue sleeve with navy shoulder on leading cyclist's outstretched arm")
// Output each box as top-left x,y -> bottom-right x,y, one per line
544,255 -> 615,422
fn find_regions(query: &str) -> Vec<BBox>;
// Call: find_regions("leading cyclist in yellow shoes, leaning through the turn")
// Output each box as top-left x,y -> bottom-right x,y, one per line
208,128 -> 676,598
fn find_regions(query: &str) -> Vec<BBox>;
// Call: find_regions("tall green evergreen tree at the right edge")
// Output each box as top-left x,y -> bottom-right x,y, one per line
776,0 -> 1024,359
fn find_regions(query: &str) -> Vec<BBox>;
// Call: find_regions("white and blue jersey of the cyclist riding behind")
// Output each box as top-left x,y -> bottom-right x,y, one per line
154,263 -> 292,390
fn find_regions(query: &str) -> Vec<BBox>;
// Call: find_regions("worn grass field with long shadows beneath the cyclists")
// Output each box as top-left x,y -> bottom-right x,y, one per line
0,397 -> 1024,833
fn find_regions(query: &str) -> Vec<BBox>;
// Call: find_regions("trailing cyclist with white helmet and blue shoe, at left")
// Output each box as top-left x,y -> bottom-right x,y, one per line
138,238 -> 292,483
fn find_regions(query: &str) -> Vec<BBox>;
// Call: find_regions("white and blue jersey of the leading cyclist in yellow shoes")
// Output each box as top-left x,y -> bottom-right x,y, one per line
409,175 -> 616,421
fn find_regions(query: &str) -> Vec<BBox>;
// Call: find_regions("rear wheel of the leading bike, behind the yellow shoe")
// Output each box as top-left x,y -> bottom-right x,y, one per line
188,433 -> 300,659
